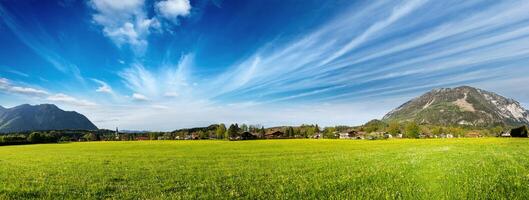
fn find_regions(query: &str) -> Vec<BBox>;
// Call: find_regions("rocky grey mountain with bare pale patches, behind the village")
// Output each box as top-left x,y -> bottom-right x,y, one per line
383,86 -> 529,126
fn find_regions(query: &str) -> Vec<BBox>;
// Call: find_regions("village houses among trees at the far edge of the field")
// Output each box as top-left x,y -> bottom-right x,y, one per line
118,124 -> 528,141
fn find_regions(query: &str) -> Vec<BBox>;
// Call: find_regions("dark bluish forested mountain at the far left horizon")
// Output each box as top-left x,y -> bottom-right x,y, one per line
0,104 -> 97,133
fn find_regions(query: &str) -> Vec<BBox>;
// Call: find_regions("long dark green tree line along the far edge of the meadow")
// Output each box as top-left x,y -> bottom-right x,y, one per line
0,120 -> 513,145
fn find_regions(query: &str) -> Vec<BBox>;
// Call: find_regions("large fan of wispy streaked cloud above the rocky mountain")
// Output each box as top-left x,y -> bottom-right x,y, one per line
205,1 -> 529,106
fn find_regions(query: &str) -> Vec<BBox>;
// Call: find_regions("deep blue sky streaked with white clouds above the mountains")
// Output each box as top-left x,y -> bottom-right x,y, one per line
0,0 -> 529,131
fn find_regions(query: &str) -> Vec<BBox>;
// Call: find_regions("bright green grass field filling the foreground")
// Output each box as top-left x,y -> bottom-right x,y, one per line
0,138 -> 529,199
